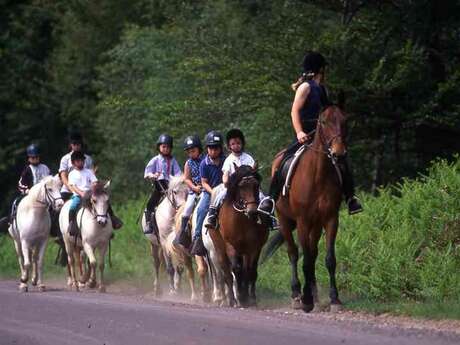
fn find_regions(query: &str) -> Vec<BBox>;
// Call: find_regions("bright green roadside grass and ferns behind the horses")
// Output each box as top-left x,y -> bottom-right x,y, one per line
0,159 -> 460,319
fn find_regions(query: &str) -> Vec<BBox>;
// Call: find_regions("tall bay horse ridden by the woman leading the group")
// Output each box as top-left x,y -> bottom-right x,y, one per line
271,105 -> 346,312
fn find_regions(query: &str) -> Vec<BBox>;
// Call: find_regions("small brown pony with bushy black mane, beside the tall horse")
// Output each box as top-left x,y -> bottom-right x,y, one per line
210,165 -> 268,306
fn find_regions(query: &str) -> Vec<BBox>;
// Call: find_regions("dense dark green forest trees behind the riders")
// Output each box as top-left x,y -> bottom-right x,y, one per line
0,0 -> 460,213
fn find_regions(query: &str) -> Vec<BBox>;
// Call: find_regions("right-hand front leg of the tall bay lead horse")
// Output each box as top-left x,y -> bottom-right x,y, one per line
326,217 -> 342,312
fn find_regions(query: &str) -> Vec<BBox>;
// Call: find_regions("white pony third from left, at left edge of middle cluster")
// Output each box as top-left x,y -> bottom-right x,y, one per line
142,175 -> 188,295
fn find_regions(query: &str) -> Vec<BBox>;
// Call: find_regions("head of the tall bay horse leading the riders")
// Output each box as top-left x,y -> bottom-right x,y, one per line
316,105 -> 347,157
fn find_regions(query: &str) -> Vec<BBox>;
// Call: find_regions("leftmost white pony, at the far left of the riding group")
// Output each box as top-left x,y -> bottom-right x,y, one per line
8,176 -> 64,292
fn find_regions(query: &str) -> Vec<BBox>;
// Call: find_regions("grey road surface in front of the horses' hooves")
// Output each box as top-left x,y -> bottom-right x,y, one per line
0,281 -> 460,345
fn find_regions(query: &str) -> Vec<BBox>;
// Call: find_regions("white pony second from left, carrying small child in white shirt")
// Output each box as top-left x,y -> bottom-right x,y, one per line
59,181 -> 113,292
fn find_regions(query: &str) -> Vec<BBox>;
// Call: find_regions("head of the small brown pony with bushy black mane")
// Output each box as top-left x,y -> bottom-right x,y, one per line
227,165 -> 261,218
